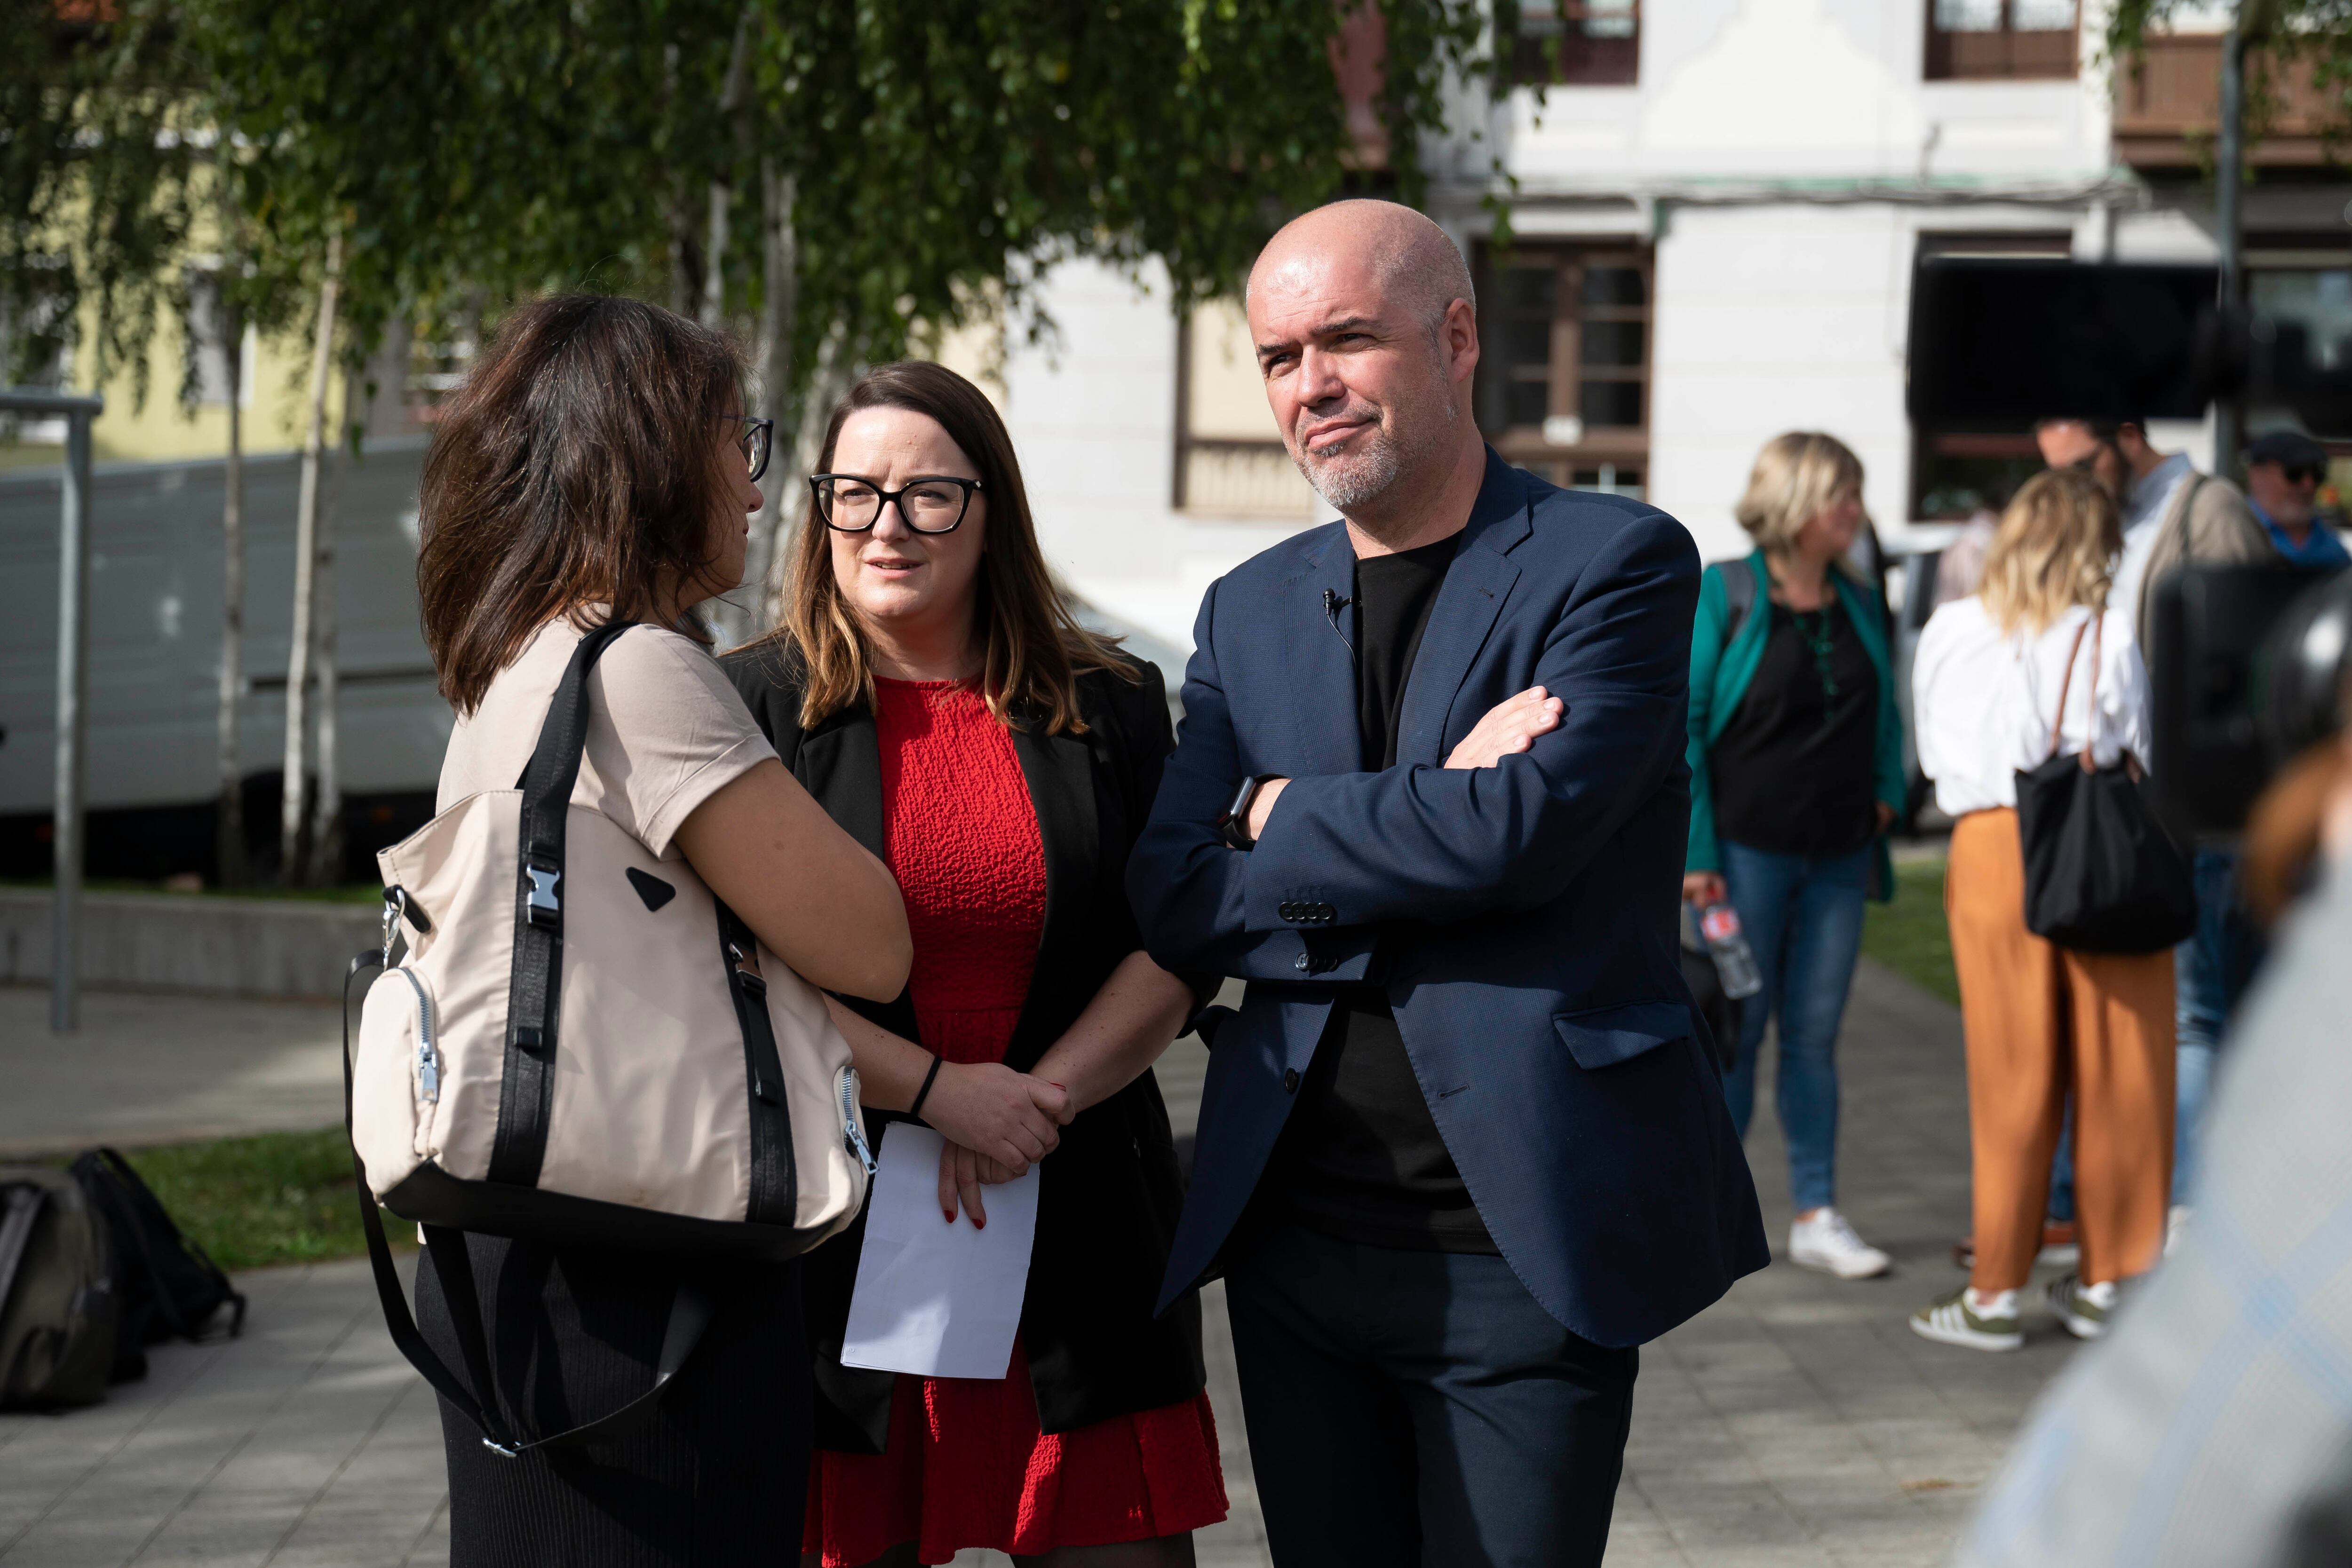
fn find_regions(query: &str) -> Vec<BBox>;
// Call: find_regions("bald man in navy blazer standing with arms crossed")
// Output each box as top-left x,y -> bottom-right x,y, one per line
1127,202 -> 1766,1568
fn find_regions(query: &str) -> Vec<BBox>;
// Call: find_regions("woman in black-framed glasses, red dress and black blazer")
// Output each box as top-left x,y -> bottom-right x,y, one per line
727,362 -> 1225,1568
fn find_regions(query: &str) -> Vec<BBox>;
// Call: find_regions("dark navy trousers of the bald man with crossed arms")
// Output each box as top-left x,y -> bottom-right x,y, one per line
1225,1218 -> 1639,1568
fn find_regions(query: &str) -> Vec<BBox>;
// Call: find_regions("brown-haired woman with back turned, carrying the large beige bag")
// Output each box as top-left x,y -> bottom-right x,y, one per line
416,296 -> 913,1568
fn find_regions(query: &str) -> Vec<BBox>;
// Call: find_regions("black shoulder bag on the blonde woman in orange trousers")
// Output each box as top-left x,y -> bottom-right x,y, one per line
2018,611 -> 2197,952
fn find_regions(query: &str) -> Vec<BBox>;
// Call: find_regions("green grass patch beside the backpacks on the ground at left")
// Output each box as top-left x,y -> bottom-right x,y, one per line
129,1126 -> 416,1269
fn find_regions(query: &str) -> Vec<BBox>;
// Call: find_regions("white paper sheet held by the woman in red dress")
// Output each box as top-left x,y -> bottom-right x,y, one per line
842,1121 -> 1037,1378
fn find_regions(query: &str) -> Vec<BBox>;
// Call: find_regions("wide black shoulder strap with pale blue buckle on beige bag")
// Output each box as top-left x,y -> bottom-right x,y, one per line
489,621 -> 635,1187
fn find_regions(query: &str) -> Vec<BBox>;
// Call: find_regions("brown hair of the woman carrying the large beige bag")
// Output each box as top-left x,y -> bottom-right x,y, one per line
416,294 -> 743,715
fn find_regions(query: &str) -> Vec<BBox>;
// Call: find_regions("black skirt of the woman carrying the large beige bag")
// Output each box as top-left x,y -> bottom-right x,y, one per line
416,1236 -> 809,1568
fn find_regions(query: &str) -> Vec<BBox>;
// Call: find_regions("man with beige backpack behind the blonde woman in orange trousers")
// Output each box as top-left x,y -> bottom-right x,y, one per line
2034,419 -> 2281,1225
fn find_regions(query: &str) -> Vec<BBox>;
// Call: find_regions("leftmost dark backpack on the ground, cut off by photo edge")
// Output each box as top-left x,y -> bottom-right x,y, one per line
0,1166 -> 120,1410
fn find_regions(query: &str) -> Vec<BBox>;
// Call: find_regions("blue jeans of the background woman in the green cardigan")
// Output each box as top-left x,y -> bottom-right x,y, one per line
1722,839 -> 1870,1213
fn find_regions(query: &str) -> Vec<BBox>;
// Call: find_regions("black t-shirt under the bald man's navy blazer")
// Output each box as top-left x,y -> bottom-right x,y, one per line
1265,534 -> 1496,1253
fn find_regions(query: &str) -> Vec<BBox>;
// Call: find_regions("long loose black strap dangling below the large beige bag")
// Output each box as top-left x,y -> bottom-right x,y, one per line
343,945 -> 710,1460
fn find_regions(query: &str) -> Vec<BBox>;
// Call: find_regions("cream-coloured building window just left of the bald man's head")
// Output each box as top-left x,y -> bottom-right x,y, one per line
1174,299 -> 1329,522
